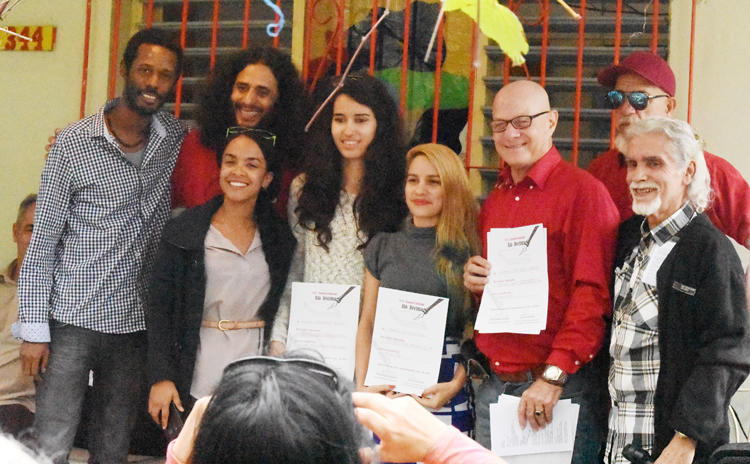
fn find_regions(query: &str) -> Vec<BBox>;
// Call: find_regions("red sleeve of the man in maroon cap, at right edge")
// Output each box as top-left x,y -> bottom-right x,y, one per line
704,152 -> 750,248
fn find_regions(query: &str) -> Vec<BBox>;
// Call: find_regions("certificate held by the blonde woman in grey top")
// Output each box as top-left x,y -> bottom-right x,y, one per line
365,287 -> 448,395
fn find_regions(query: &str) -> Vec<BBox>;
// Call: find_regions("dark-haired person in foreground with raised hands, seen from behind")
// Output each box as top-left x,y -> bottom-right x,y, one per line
166,353 -> 505,464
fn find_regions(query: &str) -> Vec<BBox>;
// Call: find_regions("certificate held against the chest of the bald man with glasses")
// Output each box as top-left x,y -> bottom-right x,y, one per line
474,224 -> 549,334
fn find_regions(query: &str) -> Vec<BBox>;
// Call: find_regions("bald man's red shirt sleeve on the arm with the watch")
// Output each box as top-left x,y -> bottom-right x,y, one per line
547,174 -> 620,373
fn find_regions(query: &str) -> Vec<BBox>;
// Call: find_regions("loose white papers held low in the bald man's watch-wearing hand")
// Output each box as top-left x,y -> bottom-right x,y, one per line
490,395 -> 579,464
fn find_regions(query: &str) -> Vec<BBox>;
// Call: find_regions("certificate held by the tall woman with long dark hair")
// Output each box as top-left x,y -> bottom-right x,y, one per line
287,282 -> 360,380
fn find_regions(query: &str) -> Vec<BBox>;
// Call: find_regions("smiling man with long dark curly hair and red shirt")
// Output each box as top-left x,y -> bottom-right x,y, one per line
172,47 -> 308,213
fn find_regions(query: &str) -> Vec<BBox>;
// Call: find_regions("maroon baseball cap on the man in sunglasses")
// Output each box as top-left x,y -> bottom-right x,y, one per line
597,51 -> 675,97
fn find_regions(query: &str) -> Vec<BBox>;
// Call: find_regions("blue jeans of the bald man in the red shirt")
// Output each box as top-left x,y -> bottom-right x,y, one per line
475,367 -> 601,464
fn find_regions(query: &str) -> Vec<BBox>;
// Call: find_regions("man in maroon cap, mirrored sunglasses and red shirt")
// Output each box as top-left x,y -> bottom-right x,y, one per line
588,51 -> 750,248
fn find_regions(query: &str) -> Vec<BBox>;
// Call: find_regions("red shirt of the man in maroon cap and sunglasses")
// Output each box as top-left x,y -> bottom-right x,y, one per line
588,150 -> 750,246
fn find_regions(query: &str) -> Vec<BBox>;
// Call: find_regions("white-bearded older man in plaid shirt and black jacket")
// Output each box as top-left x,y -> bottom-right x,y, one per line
605,118 -> 750,464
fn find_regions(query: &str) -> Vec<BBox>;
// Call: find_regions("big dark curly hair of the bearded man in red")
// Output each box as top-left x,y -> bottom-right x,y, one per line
197,46 -> 309,169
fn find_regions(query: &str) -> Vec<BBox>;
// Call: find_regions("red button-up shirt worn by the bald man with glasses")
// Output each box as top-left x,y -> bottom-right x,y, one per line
475,147 -> 619,374
